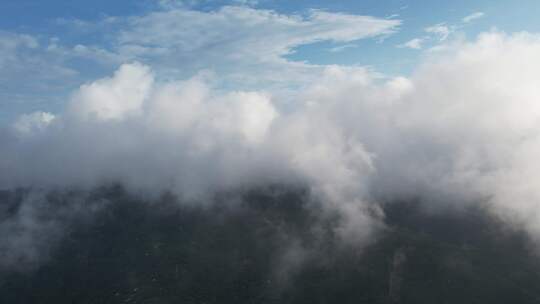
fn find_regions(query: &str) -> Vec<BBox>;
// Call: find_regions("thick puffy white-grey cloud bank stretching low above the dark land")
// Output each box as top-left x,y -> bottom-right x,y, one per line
5,32 -> 540,264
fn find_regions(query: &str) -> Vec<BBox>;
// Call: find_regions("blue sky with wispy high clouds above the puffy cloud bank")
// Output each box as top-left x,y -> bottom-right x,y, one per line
0,0 -> 540,123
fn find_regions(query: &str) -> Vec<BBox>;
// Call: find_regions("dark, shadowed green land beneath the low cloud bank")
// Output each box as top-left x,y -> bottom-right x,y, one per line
0,187 -> 540,304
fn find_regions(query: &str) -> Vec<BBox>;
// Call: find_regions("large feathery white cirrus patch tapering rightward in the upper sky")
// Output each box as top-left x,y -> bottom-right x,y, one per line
115,6 -> 400,75
